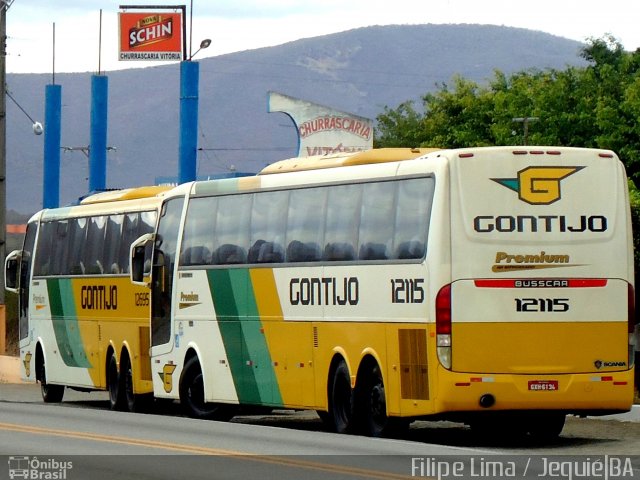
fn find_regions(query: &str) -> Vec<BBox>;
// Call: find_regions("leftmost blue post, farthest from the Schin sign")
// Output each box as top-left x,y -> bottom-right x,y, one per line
42,85 -> 62,208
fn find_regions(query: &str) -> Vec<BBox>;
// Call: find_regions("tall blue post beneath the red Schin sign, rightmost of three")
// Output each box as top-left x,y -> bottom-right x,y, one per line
178,61 -> 200,183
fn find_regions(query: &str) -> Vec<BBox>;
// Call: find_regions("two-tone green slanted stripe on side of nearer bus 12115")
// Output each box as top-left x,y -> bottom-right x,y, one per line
207,268 -> 282,406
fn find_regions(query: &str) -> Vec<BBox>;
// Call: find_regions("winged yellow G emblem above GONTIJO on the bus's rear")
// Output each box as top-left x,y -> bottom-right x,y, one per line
491,167 -> 585,205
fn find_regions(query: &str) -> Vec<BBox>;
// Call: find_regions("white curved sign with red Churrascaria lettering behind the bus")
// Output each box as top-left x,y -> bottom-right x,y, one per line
268,92 -> 373,157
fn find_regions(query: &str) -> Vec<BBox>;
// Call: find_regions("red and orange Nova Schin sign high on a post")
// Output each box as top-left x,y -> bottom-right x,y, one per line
119,12 -> 182,61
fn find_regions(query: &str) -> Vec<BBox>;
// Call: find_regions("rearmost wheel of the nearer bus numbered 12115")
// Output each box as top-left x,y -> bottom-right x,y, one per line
356,365 -> 390,437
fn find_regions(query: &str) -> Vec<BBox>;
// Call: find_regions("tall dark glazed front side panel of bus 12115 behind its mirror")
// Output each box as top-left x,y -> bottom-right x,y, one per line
151,197 -> 184,357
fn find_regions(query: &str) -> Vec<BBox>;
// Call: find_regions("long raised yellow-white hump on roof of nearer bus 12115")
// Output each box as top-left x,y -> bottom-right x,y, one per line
258,148 -> 442,175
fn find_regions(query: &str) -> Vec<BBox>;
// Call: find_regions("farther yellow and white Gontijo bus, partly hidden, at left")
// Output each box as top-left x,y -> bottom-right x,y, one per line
5,187 -> 168,411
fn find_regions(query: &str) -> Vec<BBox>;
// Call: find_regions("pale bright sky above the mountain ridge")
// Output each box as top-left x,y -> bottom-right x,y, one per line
5,0 -> 640,73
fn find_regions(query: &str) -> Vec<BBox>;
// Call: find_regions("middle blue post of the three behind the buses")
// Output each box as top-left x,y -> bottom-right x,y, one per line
89,75 -> 109,192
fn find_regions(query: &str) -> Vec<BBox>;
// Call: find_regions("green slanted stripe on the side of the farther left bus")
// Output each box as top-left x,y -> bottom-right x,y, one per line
47,279 -> 91,368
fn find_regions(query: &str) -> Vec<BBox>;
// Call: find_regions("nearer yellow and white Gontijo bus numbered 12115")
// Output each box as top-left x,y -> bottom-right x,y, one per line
130,147 -> 636,438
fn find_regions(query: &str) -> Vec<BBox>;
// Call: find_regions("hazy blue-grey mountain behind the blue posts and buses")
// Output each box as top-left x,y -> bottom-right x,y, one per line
7,25 -> 584,213
